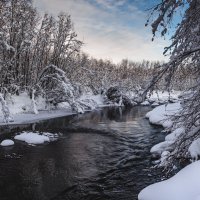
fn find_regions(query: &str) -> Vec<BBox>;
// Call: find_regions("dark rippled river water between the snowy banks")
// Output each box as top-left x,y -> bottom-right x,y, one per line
0,107 -> 164,200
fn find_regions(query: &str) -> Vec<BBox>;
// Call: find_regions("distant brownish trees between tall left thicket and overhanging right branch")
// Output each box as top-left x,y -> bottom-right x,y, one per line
67,53 -> 167,94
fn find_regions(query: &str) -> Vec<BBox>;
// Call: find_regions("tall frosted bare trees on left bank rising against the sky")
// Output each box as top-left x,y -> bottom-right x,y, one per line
0,0 -> 82,93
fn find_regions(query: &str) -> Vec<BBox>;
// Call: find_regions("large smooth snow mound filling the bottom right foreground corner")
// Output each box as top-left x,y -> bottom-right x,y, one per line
138,161 -> 200,200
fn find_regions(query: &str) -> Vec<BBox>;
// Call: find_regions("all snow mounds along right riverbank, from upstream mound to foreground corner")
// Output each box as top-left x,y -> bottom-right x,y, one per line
138,102 -> 200,200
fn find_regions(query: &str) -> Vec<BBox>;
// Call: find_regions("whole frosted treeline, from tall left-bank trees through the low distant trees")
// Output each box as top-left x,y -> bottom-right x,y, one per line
0,0 -> 195,104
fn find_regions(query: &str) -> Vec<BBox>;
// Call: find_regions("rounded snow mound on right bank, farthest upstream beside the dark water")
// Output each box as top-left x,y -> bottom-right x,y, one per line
146,102 -> 181,128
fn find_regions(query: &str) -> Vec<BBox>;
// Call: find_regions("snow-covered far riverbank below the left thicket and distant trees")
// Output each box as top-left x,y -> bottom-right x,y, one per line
0,91 -> 180,126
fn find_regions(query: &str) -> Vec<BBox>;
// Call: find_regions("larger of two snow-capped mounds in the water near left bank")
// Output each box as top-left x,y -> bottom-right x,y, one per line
14,132 -> 58,144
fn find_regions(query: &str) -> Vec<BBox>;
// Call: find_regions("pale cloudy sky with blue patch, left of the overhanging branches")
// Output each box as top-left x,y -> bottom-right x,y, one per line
34,0 -> 169,63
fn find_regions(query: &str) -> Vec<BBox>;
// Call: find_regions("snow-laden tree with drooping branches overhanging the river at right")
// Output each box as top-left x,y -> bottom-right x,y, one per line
147,0 -> 200,168
